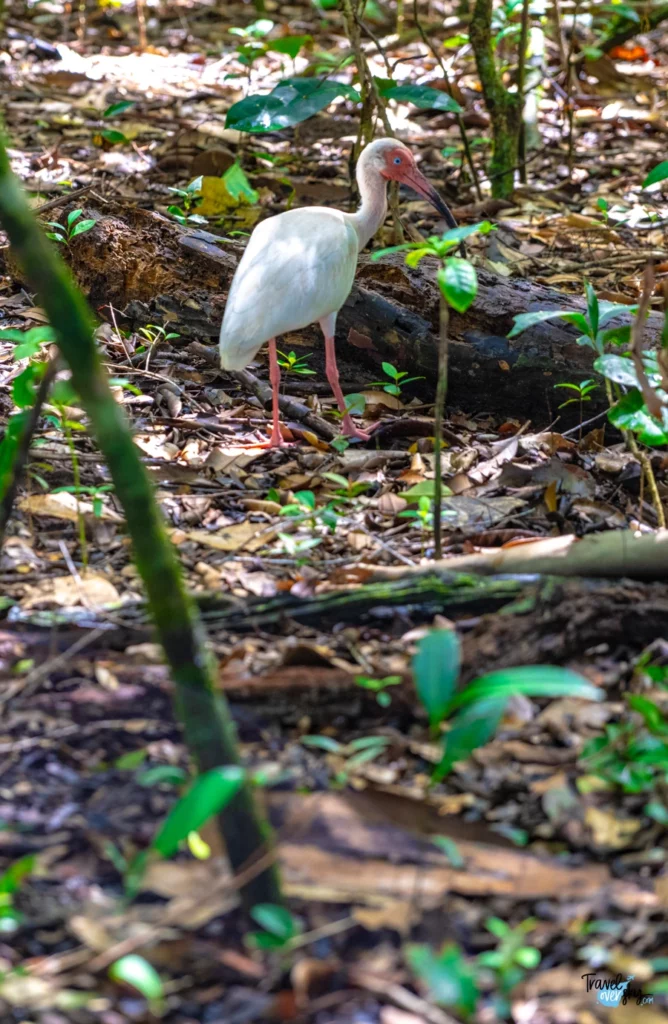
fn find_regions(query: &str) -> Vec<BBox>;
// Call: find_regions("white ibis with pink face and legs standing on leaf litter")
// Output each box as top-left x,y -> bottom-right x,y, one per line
220,138 -> 457,447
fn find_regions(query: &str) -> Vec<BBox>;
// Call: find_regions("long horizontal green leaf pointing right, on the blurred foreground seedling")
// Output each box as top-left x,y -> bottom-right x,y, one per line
448,665 -> 603,712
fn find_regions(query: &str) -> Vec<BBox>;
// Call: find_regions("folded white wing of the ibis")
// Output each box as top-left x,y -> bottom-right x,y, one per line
220,207 -> 358,370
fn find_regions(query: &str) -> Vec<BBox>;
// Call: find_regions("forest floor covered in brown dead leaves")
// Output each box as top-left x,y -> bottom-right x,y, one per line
0,0 -> 668,1024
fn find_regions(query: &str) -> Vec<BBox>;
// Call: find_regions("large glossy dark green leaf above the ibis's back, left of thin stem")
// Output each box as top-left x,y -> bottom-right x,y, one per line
225,78 -> 360,132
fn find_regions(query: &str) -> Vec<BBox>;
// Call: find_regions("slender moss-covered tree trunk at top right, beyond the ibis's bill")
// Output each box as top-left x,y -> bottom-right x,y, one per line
469,0 -> 521,199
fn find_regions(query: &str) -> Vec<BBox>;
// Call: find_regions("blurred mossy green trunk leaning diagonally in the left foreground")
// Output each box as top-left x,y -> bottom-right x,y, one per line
0,136 -> 281,908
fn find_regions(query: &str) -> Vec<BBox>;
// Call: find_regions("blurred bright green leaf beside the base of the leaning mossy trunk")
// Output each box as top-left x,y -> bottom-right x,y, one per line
152,765 -> 244,857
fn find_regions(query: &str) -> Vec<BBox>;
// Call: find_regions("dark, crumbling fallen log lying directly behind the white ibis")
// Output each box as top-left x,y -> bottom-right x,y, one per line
19,206 -> 662,423
